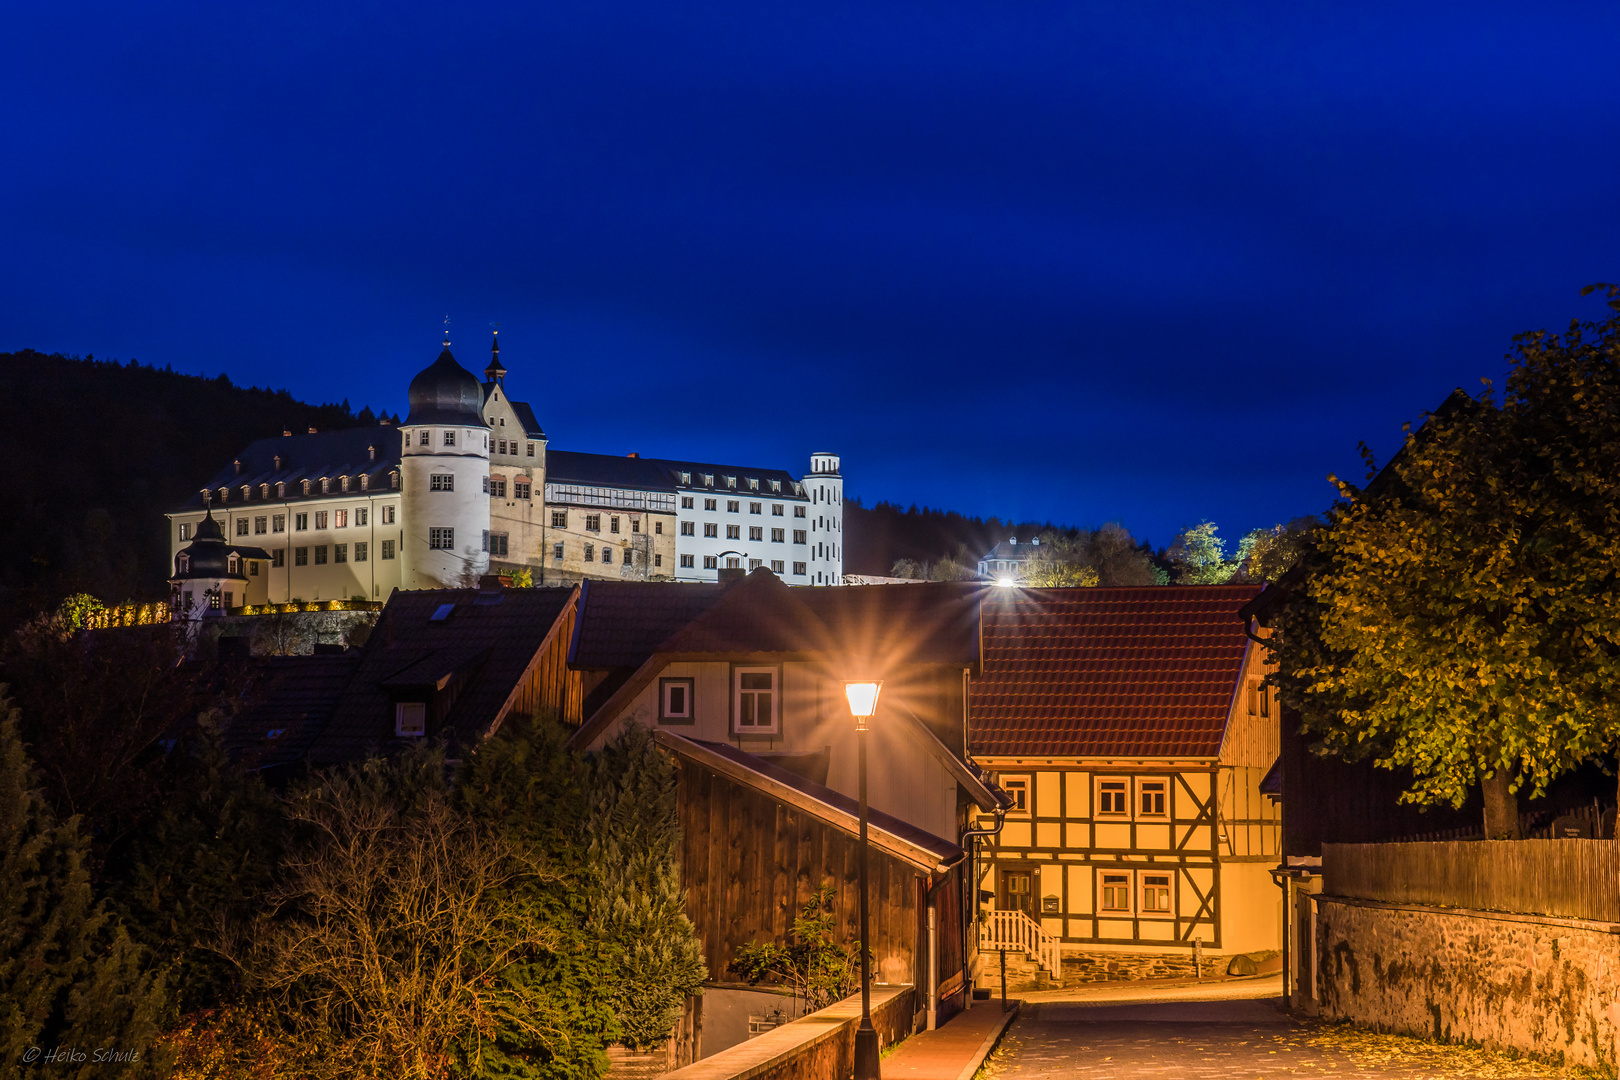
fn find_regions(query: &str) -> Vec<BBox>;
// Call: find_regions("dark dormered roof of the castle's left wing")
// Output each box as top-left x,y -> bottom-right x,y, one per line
180,424 -> 400,510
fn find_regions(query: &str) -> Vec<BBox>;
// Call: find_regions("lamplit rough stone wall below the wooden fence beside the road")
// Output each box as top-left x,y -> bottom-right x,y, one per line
1317,895 -> 1620,1067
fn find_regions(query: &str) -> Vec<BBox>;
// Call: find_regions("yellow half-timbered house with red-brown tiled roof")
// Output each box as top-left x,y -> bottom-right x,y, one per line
969,585 -> 1281,984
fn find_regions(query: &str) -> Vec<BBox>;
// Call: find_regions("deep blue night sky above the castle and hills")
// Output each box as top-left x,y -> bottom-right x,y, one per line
0,0 -> 1620,544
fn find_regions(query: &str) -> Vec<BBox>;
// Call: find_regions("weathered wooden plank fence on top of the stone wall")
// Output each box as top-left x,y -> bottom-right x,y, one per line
1322,840 -> 1620,923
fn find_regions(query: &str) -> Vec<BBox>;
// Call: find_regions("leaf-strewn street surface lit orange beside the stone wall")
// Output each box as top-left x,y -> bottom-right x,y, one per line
978,1001 -> 1581,1080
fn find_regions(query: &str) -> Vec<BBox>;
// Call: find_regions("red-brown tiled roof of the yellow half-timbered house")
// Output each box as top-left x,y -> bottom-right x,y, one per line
969,585 -> 1260,758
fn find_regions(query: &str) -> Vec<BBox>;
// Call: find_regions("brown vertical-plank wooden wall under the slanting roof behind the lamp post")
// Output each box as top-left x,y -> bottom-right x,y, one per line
679,761 -> 920,983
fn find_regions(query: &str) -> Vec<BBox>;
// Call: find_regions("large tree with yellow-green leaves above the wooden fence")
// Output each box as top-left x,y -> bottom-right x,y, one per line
1270,285 -> 1620,839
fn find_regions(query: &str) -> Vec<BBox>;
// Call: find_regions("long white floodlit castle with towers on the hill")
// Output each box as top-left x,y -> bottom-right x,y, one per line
168,333 -> 844,610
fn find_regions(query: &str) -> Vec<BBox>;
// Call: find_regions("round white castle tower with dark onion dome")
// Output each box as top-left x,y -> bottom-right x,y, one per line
400,338 -> 489,589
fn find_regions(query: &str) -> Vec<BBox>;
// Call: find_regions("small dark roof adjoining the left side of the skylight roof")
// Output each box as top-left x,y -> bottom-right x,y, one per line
222,649 -> 360,769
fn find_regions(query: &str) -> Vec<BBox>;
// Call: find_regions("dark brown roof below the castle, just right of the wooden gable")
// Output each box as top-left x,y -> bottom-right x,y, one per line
569,581 -> 726,669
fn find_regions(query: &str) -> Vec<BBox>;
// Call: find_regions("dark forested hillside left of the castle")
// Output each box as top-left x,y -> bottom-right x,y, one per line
0,350 -> 374,622
